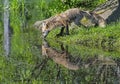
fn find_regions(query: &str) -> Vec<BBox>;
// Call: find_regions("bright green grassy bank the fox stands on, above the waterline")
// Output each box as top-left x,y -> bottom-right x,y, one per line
47,23 -> 120,50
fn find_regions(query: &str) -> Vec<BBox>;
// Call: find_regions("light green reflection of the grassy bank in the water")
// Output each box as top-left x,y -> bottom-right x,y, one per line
48,39 -> 120,58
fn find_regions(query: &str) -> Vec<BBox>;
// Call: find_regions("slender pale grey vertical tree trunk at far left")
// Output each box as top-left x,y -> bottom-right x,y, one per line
4,0 -> 10,56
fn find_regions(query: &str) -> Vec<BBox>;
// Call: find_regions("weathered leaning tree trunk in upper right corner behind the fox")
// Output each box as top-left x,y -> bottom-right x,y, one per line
93,0 -> 120,24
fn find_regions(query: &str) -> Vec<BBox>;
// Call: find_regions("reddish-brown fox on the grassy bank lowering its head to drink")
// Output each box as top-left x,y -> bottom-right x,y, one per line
34,8 -> 105,37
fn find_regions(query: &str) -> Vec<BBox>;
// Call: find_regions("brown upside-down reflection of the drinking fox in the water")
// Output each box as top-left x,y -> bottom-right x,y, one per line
42,41 -> 79,70
